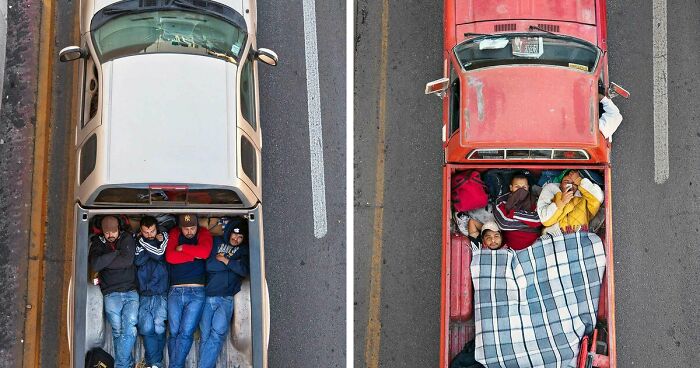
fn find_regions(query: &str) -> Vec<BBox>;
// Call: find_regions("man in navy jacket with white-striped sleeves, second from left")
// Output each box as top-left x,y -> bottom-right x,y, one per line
134,216 -> 169,368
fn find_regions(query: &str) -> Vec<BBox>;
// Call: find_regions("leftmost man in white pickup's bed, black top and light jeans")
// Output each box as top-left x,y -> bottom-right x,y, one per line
88,216 -> 139,368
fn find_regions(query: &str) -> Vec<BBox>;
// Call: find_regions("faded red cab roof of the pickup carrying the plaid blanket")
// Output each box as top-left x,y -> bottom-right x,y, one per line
461,65 -> 598,148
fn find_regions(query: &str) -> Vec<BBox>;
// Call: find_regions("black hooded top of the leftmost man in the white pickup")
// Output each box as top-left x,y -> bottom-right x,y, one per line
88,231 -> 137,295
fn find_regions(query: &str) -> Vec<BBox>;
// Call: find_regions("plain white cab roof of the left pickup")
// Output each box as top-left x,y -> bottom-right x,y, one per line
102,54 -> 237,185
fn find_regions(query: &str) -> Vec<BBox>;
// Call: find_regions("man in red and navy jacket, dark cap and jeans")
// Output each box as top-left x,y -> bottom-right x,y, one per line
165,214 -> 212,368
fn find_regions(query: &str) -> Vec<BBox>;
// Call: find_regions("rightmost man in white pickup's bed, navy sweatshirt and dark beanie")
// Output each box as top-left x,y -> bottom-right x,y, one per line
199,217 -> 250,368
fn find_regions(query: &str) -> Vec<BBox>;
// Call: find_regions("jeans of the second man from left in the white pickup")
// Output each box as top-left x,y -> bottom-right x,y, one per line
138,295 -> 168,368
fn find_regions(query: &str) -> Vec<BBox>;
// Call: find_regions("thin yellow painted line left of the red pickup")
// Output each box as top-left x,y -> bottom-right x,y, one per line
365,0 -> 389,368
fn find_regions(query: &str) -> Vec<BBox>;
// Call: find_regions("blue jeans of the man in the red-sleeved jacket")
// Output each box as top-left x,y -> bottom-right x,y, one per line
168,286 -> 204,368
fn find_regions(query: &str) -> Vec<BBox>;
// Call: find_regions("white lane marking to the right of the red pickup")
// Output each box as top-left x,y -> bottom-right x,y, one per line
652,0 -> 669,184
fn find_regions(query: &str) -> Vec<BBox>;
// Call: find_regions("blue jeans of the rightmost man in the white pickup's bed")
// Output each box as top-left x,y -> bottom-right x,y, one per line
199,296 -> 233,368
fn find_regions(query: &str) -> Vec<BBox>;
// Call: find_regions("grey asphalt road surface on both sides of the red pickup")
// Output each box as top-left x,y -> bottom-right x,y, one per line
354,0 -> 700,368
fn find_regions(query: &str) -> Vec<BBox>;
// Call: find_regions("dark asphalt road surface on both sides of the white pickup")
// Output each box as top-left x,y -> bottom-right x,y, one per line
0,0 -> 346,367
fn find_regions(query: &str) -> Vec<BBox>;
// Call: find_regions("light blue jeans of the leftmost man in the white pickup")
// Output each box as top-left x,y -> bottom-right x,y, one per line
104,290 -> 139,368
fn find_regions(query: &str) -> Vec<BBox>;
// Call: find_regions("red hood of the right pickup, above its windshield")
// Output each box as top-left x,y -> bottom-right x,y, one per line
455,0 -> 596,24
